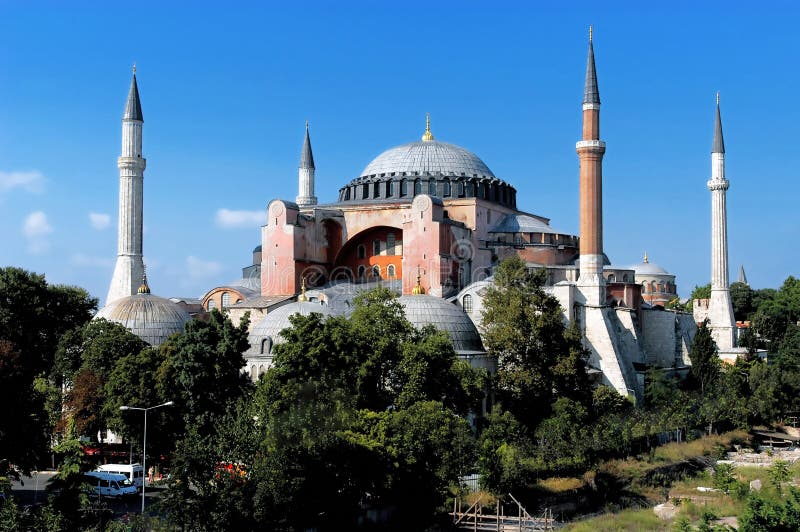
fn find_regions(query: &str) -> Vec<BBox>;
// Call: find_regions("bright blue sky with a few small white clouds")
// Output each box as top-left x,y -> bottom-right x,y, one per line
0,0 -> 800,302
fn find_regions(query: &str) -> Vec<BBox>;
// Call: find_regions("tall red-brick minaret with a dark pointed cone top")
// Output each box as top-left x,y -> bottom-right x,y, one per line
575,26 -> 606,306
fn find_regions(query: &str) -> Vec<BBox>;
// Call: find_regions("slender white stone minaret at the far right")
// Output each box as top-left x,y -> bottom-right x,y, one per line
707,93 -> 736,350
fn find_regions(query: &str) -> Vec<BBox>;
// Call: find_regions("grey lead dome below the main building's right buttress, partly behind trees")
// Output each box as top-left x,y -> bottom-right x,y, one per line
397,295 -> 485,354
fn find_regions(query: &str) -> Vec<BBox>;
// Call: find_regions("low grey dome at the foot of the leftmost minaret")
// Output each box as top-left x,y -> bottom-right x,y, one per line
95,294 -> 191,346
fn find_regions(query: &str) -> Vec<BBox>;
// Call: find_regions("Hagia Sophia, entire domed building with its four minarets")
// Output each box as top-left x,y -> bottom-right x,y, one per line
89,28 -> 735,397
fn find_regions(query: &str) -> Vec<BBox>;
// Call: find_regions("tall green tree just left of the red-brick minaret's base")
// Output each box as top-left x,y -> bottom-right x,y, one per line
483,256 -> 591,428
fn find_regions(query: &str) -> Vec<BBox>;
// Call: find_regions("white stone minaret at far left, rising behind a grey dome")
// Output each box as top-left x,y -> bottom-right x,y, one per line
106,65 -> 146,303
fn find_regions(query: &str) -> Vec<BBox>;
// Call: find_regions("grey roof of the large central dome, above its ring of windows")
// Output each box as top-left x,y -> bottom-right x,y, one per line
361,140 -> 495,178
